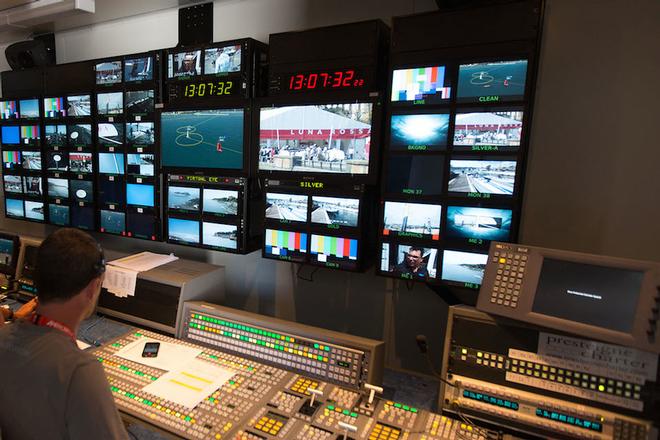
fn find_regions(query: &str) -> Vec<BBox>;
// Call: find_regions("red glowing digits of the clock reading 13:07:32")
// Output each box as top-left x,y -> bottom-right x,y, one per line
283,69 -> 367,91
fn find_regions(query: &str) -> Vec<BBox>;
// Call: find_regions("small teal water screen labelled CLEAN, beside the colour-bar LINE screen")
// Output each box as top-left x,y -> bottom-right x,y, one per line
456,60 -> 527,102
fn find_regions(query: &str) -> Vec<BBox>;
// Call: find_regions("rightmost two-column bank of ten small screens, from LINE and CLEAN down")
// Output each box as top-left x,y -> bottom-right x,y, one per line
378,55 -> 530,289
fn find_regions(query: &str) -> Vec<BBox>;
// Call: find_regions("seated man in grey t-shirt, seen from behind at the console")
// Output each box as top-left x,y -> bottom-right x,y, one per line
0,229 -> 127,440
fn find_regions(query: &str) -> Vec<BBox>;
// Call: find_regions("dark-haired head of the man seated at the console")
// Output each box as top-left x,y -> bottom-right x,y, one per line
35,228 -> 105,310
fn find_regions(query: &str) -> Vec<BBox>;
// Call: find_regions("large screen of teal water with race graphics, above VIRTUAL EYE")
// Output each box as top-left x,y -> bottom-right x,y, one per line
160,108 -> 244,170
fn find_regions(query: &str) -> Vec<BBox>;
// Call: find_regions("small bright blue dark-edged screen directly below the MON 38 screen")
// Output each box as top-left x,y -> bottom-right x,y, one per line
445,206 -> 513,244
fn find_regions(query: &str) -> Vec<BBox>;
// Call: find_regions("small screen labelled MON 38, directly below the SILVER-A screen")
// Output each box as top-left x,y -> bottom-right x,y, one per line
448,159 -> 516,196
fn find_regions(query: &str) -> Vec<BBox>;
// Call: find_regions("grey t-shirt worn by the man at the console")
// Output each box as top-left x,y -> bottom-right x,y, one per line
0,321 -> 128,440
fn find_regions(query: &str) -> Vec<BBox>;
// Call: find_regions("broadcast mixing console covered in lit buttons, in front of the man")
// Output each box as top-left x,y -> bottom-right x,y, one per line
93,303 -> 502,440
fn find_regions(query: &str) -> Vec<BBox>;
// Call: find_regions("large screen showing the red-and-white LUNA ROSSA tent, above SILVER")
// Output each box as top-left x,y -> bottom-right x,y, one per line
259,102 -> 373,175
